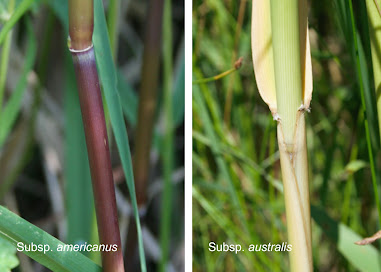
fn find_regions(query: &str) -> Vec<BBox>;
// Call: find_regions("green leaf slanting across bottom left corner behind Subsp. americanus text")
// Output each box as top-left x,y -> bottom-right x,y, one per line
0,206 -> 101,272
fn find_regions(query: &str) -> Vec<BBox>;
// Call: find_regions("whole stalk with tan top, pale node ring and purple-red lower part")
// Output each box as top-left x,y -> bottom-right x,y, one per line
69,0 -> 124,272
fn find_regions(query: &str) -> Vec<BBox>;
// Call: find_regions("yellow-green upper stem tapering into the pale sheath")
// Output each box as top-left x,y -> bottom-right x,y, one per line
271,0 -> 302,150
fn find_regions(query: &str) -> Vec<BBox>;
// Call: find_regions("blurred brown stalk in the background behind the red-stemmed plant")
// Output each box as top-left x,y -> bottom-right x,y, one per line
134,0 -> 164,208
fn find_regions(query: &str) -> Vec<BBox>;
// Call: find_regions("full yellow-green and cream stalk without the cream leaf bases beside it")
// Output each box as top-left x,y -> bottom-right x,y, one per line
271,0 -> 312,271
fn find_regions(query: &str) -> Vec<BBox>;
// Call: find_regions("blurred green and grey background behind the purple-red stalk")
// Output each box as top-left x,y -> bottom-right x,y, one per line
0,0 -> 184,272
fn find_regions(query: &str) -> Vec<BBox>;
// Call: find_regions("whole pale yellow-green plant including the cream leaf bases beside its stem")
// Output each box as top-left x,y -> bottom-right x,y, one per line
252,0 -> 312,271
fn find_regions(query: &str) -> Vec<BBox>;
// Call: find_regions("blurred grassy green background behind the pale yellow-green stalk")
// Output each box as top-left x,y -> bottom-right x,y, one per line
192,0 -> 381,271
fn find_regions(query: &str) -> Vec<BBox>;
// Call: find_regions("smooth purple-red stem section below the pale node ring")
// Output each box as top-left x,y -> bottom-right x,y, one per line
71,48 -> 124,272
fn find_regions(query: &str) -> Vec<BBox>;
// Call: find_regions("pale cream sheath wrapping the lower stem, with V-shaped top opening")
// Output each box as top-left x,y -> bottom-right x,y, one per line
277,111 -> 312,271
